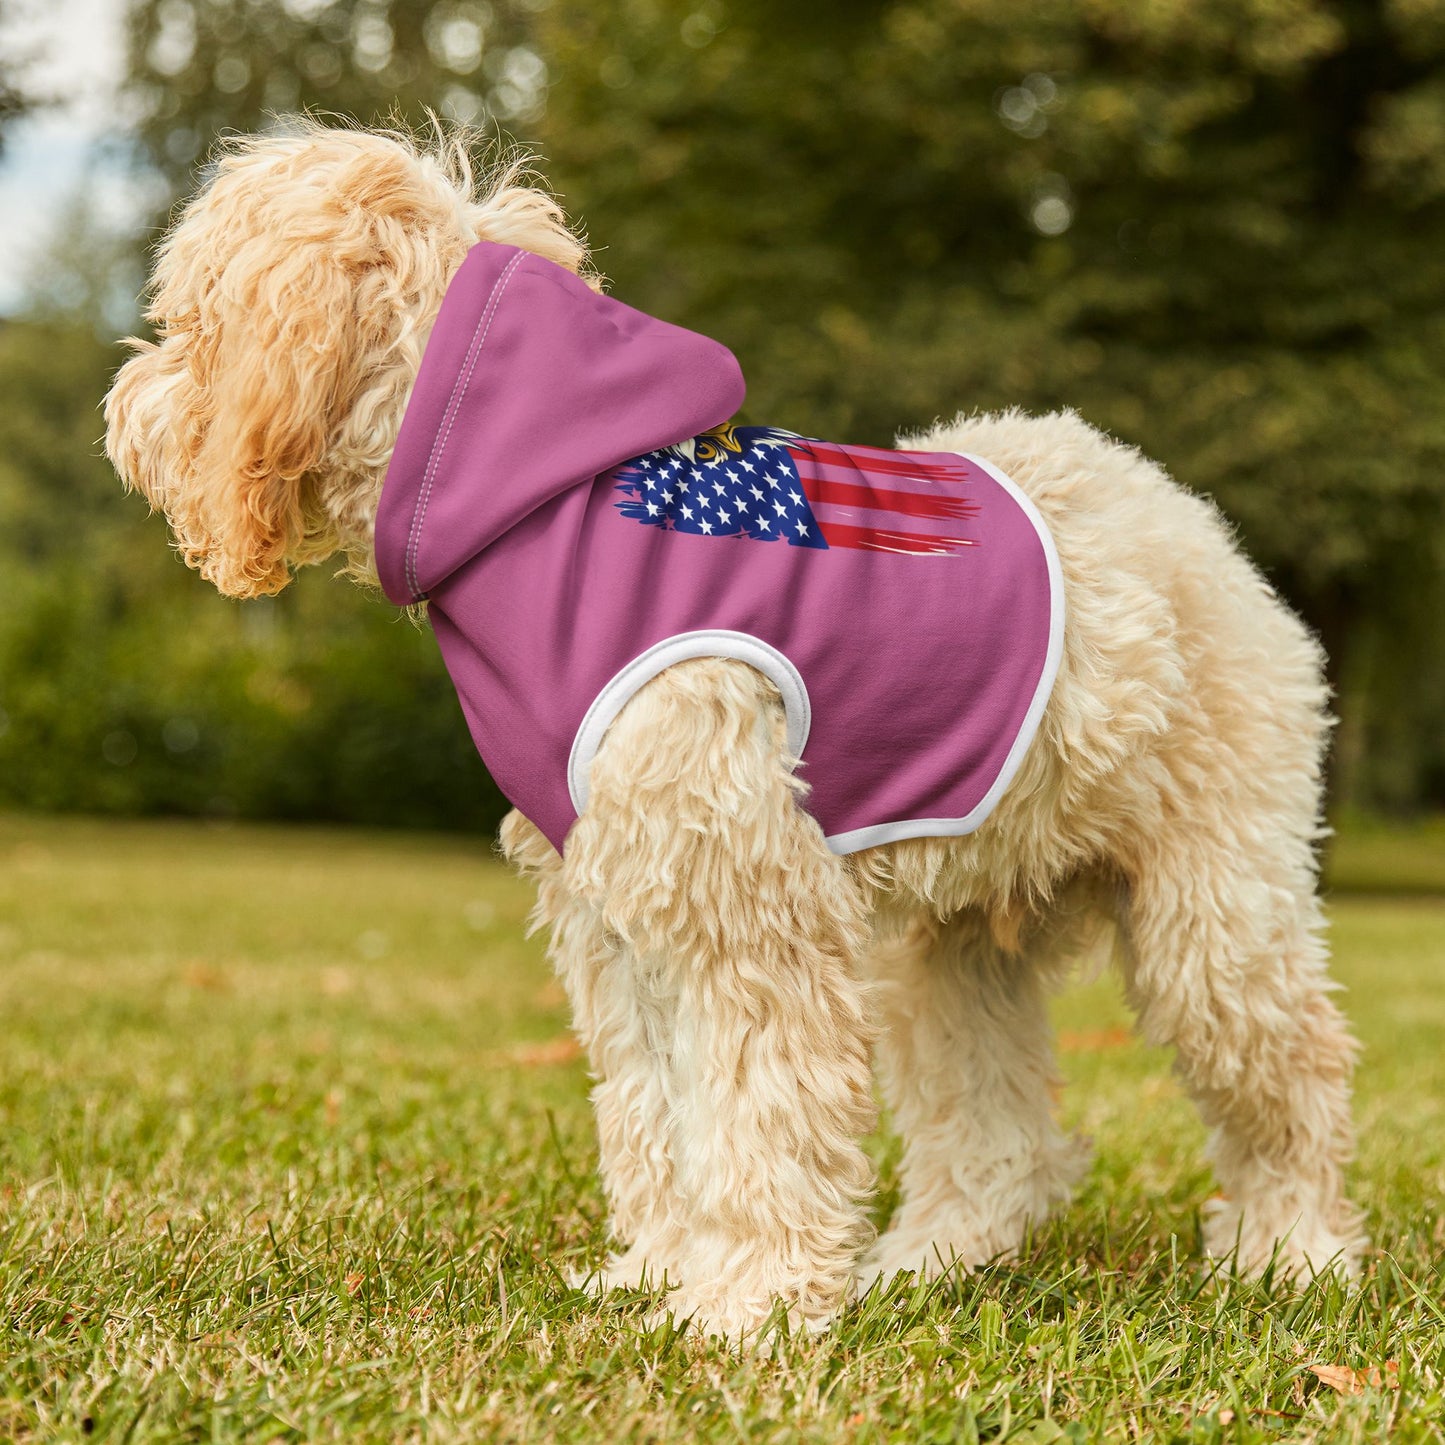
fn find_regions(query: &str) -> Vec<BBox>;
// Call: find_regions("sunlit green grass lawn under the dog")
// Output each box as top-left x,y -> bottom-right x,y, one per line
0,818 -> 1445,1445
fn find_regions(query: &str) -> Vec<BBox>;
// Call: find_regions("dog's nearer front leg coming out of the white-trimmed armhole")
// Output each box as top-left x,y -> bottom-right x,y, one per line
564,659 -> 874,1340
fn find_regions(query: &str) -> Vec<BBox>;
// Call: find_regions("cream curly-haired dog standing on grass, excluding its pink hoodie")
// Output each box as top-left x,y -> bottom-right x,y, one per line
105,126 -> 1364,1338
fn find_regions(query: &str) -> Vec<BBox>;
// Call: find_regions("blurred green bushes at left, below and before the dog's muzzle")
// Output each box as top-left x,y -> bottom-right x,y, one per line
0,315 -> 506,829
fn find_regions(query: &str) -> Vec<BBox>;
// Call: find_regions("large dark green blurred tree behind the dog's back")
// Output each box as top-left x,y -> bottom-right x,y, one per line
538,0 -> 1445,801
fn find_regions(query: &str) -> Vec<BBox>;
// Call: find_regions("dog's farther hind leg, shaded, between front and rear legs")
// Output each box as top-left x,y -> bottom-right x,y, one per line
860,912 -> 1088,1283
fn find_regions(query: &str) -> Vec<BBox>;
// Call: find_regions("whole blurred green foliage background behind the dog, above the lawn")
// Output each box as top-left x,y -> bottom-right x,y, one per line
0,0 -> 1445,825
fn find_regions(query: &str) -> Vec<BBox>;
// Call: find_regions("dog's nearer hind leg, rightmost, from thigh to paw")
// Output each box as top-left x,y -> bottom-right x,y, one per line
1094,578 -> 1364,1274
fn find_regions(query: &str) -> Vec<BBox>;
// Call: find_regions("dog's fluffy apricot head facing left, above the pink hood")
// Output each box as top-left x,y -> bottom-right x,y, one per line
105,123 -> 585,597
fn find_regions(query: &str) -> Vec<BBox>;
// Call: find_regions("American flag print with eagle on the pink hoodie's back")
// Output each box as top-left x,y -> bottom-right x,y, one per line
611,426 -> 978,556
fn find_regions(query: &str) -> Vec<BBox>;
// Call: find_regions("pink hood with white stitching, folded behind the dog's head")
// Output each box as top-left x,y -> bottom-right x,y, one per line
376,241 -> 744,607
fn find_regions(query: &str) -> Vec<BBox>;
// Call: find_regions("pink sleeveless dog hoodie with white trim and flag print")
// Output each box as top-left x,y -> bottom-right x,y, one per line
376,241 -> 1064,853
